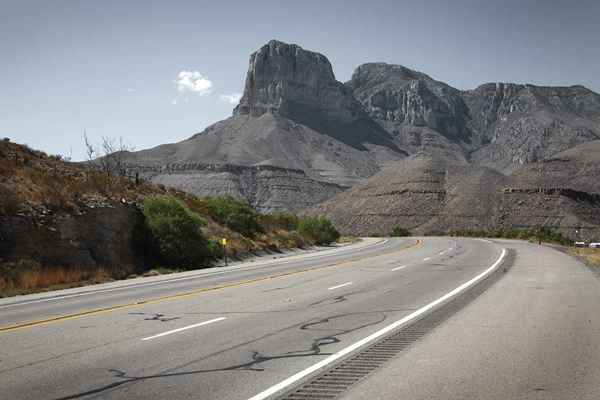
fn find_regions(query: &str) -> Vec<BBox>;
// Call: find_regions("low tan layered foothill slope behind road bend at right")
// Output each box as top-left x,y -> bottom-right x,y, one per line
308,148 -> 600,239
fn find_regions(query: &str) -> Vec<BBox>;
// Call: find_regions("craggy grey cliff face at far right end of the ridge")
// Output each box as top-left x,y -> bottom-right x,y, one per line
463,83 -> 600,172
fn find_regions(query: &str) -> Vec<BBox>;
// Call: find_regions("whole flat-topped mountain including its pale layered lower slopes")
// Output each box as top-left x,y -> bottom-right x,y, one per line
126,40 -> 407,211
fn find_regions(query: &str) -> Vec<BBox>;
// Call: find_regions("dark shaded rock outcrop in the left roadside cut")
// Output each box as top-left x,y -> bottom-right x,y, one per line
0,204 -> 143,274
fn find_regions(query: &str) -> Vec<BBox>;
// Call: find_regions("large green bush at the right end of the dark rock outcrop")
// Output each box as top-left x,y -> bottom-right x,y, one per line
143,196 -> 211,268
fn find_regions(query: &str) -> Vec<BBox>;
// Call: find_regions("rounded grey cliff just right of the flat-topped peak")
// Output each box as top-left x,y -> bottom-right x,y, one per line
346,63 -> 473,158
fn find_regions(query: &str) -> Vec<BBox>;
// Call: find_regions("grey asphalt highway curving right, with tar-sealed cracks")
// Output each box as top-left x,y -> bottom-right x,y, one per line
0,237 -> 600,400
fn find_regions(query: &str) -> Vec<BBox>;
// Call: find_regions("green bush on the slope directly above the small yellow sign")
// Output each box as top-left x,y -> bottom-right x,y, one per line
205,196 -> 264,238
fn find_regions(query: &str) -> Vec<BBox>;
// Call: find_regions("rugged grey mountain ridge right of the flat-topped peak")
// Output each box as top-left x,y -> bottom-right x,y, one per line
346,63 -> 600,173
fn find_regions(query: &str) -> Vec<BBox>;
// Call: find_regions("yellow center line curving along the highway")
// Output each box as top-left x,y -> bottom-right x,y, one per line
0,239 -> 422,333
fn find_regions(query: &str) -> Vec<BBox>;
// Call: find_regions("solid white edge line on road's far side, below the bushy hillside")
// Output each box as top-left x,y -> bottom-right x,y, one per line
0,239 -> 390,309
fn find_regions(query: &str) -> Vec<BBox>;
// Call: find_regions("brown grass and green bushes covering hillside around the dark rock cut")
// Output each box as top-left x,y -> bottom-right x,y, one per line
0,139 -> 339,297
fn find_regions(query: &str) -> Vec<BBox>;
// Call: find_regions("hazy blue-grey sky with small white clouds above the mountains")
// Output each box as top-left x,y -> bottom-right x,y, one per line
0,0 -> 600,160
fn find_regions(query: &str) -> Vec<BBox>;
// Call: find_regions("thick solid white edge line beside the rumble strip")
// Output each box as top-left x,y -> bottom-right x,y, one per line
248,249 -> 506,400
